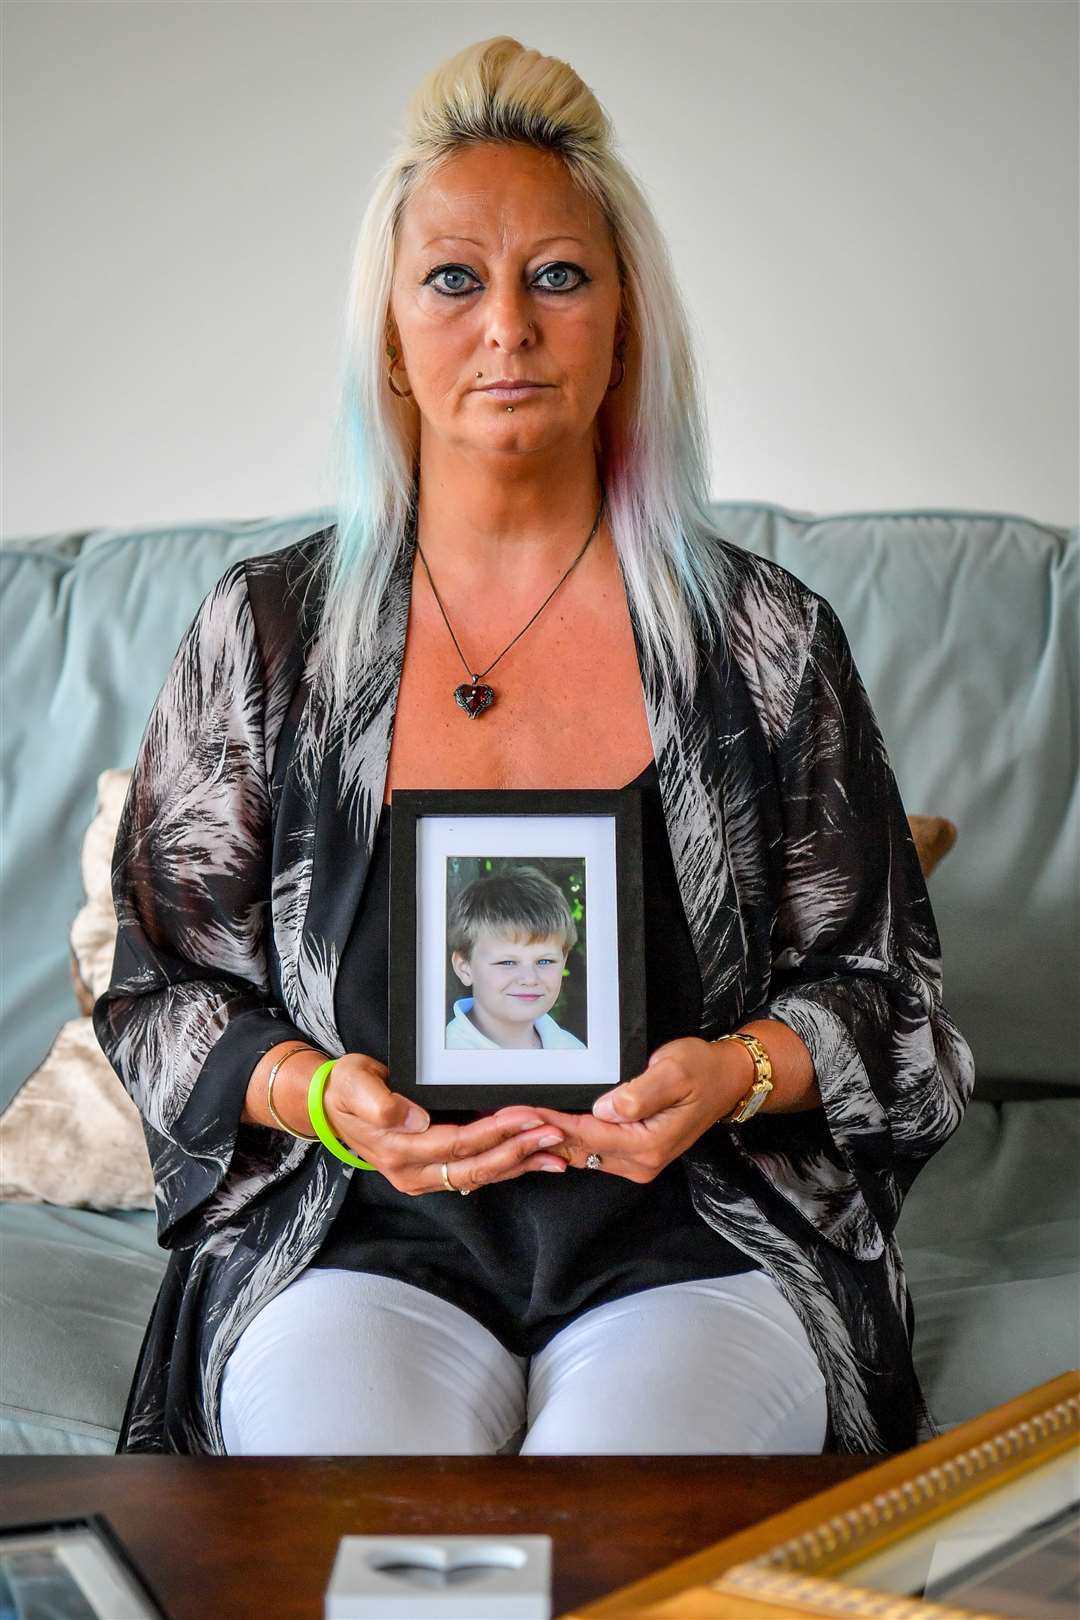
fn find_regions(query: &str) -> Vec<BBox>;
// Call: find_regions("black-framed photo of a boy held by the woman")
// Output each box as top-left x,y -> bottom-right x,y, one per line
389,787 -> 648,1113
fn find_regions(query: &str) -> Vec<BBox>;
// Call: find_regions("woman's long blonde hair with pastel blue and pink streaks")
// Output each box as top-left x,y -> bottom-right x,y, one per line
304,36 -> 744,729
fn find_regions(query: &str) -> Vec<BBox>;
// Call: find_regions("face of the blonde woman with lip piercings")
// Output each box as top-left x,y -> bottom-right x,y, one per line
389,144 -> 622,454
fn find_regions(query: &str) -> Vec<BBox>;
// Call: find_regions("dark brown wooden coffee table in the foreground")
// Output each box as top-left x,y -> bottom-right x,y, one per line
0,1456 -> 881,1620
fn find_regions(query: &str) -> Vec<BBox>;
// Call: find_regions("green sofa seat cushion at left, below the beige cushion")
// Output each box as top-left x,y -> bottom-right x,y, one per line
0,1204 -> 168,1455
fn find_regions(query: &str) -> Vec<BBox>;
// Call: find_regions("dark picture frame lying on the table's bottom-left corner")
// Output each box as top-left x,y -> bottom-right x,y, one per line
0,1513 -> 172,1620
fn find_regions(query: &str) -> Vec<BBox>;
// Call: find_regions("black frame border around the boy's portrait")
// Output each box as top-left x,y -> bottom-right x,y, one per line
387,787 -> 648,1115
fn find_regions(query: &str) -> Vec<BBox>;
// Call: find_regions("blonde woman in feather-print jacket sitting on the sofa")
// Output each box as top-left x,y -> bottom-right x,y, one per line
94,37 -> 973,1453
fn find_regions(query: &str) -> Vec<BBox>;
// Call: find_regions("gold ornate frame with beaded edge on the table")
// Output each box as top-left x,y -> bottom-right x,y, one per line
560,1372 -> 1080,1620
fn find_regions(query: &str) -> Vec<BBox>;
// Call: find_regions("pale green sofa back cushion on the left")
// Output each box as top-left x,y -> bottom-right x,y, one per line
0,510 -> 330,1108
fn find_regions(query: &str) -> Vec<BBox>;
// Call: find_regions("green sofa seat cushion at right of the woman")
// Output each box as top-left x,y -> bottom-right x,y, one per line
897,1097 -> 1080,1429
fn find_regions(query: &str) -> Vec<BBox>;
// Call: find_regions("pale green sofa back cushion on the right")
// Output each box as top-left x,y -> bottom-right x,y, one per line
712,502 -> 1080,1095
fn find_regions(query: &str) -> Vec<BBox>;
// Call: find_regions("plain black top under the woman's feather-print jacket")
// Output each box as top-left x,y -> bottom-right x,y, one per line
311,761 -> 756,1356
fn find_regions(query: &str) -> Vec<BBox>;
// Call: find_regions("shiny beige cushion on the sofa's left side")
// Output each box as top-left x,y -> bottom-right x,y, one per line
0,770 -> 154,1210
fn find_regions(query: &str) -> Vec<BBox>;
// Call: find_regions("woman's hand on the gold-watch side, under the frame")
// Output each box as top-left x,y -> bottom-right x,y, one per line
505,1035 -> 748,1183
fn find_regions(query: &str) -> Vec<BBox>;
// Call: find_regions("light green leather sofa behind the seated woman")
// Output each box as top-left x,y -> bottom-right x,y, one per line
0,504 -> 1080,1453
